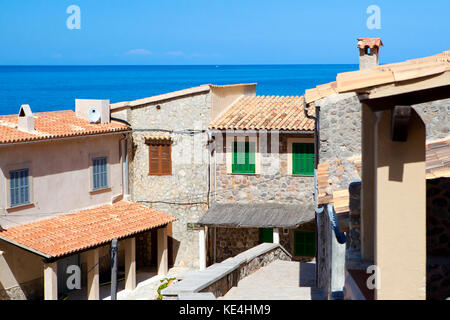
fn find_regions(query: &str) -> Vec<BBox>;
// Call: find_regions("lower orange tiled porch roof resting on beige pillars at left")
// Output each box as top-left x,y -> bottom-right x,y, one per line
0,201 -> 177,258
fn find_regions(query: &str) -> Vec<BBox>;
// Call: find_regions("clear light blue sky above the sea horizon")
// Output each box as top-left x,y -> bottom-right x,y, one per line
0,0 -> 450,65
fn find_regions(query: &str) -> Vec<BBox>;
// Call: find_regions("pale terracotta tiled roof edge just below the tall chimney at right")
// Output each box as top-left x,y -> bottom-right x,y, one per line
305,50 -> 450,103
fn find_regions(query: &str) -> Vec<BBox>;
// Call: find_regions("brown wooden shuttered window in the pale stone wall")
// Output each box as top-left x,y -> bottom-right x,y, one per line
147,140 -> 172,176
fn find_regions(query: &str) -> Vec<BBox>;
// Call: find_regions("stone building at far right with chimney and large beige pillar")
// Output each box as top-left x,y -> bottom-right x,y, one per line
305,38 -> 450,299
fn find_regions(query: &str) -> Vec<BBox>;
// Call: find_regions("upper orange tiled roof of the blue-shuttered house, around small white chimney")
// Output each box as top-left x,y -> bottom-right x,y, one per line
0,110 -> 131,144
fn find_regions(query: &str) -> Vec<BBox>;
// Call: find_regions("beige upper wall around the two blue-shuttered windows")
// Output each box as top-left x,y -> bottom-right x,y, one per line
0,134 -> 123,228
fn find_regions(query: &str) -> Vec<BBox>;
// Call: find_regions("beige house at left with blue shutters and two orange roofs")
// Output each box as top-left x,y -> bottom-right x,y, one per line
0,100 -> 175,300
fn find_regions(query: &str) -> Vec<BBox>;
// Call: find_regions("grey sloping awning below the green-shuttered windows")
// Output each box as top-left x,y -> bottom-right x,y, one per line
199,201 -> 314,228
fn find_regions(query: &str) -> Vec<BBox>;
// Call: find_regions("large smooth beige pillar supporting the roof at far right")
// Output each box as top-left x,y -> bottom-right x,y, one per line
374,110 -> 426,299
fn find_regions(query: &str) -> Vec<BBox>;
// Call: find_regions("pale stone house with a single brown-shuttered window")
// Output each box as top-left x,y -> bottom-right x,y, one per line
111,83 -> 256,269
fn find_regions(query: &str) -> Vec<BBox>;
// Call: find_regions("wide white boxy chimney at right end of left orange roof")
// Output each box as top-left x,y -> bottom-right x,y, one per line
75,99 -> 111,124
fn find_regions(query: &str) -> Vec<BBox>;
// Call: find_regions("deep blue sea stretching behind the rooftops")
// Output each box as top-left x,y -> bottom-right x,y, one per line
0,64 -> 358,114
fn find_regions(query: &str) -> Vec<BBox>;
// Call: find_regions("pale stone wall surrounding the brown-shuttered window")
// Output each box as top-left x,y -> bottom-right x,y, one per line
113,93 -> 211,268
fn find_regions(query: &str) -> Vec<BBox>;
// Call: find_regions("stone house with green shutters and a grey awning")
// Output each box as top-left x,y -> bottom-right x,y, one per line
199,96 -> 316,265
